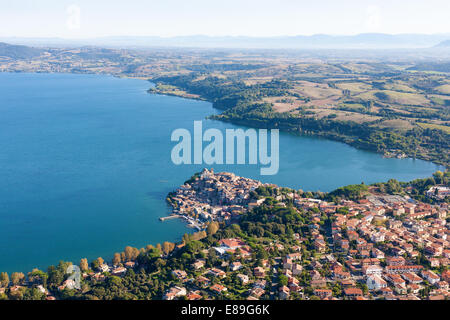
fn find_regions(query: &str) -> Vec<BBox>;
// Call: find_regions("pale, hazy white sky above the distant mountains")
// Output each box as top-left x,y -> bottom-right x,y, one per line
0,0 -> 450,38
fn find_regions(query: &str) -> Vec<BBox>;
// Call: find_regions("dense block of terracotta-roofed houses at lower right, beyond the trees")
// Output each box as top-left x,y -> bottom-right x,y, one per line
284,191 -> 450,299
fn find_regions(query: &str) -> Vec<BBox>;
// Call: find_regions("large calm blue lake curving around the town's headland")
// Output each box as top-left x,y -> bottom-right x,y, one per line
0,73 -> 439,272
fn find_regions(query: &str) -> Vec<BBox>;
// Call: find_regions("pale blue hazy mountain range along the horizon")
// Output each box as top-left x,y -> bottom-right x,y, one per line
0,33 -> 450,49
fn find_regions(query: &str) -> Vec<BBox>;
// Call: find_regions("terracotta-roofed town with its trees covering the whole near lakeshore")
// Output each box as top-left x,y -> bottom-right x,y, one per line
0,169 -> 450,300
